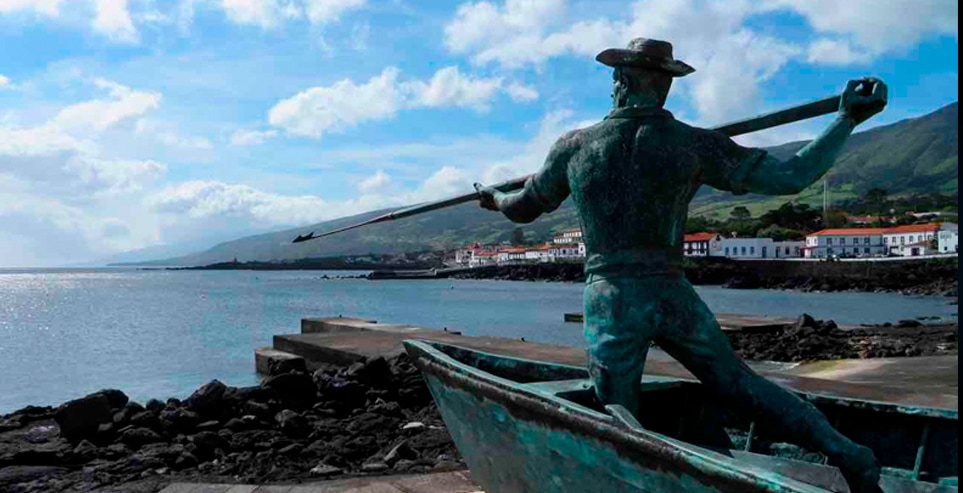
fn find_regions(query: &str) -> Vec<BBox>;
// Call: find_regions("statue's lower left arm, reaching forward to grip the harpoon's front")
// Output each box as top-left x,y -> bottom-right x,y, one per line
475,132 -> 575,223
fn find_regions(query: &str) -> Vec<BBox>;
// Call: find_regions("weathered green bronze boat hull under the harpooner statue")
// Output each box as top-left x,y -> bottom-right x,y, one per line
405,341 -> 957,493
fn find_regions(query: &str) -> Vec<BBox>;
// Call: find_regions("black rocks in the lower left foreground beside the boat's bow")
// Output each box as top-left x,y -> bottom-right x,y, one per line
0,355 -> 465,493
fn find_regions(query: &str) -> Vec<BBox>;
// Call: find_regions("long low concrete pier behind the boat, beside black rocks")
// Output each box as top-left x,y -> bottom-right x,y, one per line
260,317 -> 959,409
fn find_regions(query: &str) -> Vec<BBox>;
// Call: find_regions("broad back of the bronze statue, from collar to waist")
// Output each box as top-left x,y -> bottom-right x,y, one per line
568,112 -> 700,270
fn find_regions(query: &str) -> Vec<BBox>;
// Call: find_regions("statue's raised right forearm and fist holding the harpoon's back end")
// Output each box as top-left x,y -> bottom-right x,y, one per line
742,79 -> 887,195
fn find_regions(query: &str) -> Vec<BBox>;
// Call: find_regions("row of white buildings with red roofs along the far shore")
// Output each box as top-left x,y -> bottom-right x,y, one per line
446,216 -> 959,267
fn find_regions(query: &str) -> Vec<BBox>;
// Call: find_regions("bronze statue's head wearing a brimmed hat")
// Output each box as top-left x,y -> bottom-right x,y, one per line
595,38 -> 695,108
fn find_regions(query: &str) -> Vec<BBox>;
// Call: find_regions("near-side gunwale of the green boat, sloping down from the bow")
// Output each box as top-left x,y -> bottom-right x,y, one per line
404,340 -> 829,493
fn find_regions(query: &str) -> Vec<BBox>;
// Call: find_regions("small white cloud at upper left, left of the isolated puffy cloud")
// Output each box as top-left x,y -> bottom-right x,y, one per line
53,79 -> 161,131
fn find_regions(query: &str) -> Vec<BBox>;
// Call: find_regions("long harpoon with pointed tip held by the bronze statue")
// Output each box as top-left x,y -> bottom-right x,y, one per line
293,96 -> 840,243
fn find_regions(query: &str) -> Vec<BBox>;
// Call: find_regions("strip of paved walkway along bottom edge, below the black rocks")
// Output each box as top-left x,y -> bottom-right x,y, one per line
160,471 -> 484,493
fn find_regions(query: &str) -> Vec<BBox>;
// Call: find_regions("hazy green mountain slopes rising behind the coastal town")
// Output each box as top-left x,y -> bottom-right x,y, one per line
132,103 -> 959,265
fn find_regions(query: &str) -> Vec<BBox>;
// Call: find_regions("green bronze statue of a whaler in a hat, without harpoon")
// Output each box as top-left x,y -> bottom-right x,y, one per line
476,38 -> 887,493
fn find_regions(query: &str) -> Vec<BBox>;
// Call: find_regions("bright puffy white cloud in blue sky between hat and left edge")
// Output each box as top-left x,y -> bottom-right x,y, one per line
268,67 -> 404,138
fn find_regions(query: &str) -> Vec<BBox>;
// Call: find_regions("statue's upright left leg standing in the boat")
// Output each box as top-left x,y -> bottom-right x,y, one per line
585,276 -> 658,416
